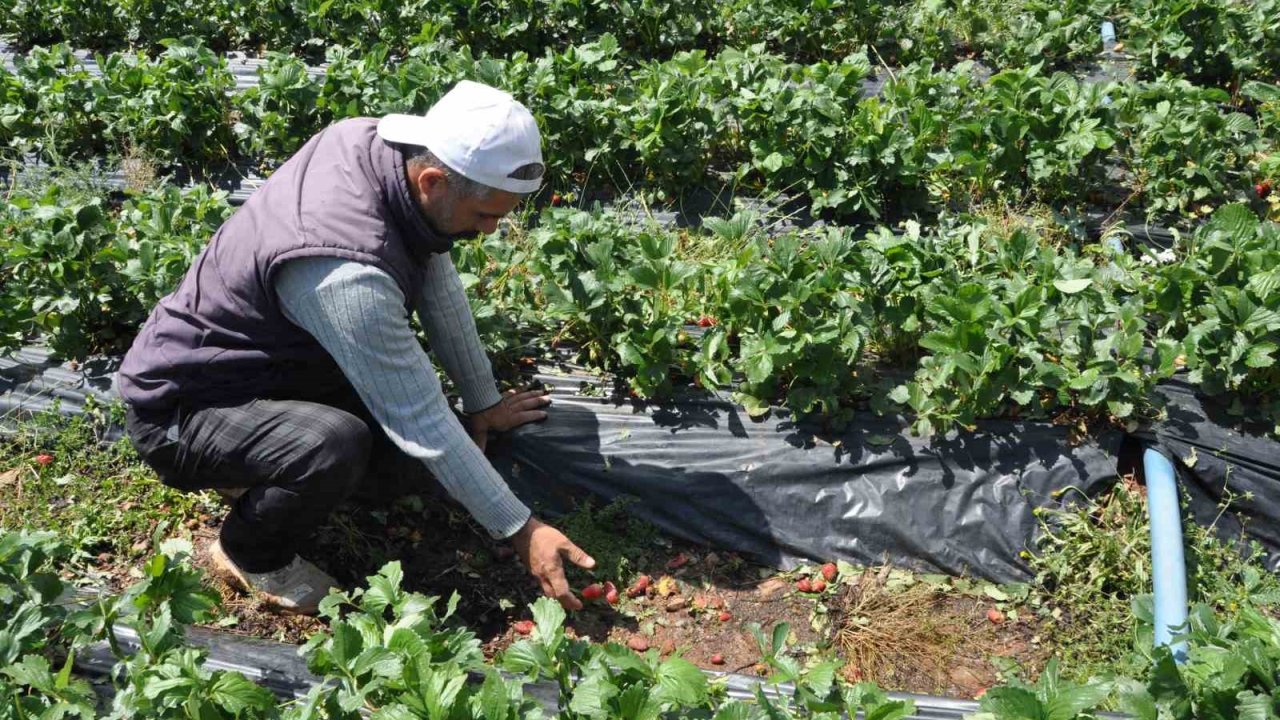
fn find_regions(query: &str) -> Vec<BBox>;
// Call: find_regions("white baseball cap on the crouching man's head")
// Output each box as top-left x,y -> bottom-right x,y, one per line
378,79 -> 544,195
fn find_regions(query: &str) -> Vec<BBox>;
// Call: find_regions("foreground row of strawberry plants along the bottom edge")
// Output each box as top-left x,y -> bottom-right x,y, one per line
0,520 -> 1280,720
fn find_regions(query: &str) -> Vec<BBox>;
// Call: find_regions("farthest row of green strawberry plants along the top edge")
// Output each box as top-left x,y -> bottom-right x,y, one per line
0,0 -> 1280,88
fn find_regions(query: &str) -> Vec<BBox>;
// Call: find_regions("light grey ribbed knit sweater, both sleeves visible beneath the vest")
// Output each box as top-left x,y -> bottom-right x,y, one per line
275,255 -> 530,538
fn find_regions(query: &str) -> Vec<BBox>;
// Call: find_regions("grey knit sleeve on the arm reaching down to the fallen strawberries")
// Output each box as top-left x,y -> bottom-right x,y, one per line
275,258 -> 530,538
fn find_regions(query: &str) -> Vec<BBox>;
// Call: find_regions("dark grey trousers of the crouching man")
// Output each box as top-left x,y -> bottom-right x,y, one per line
125,386 -> 444,573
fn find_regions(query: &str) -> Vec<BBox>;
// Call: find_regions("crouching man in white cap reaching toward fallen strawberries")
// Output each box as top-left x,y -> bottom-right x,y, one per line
118,82 -> 594,614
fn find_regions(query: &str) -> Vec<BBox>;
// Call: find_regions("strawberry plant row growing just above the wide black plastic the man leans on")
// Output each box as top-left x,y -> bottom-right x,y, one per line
0,172 -> 1280,433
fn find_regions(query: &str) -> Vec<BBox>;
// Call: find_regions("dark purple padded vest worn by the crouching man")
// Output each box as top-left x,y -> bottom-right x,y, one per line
116,118 -> 452,410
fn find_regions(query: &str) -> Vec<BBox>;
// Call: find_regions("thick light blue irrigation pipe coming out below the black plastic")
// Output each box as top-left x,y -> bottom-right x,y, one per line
1142,448 -> 1187,662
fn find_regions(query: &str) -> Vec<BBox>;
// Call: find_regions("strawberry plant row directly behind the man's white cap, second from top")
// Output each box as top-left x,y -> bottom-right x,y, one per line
0,35 -> 1280,222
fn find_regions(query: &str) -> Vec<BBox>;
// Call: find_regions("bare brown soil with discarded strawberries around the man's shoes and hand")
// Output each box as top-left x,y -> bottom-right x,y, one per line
90,484 -> 1047,698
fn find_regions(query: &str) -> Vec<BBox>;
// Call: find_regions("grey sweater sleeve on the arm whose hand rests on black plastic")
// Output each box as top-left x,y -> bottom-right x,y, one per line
417,254 -> 502,413
